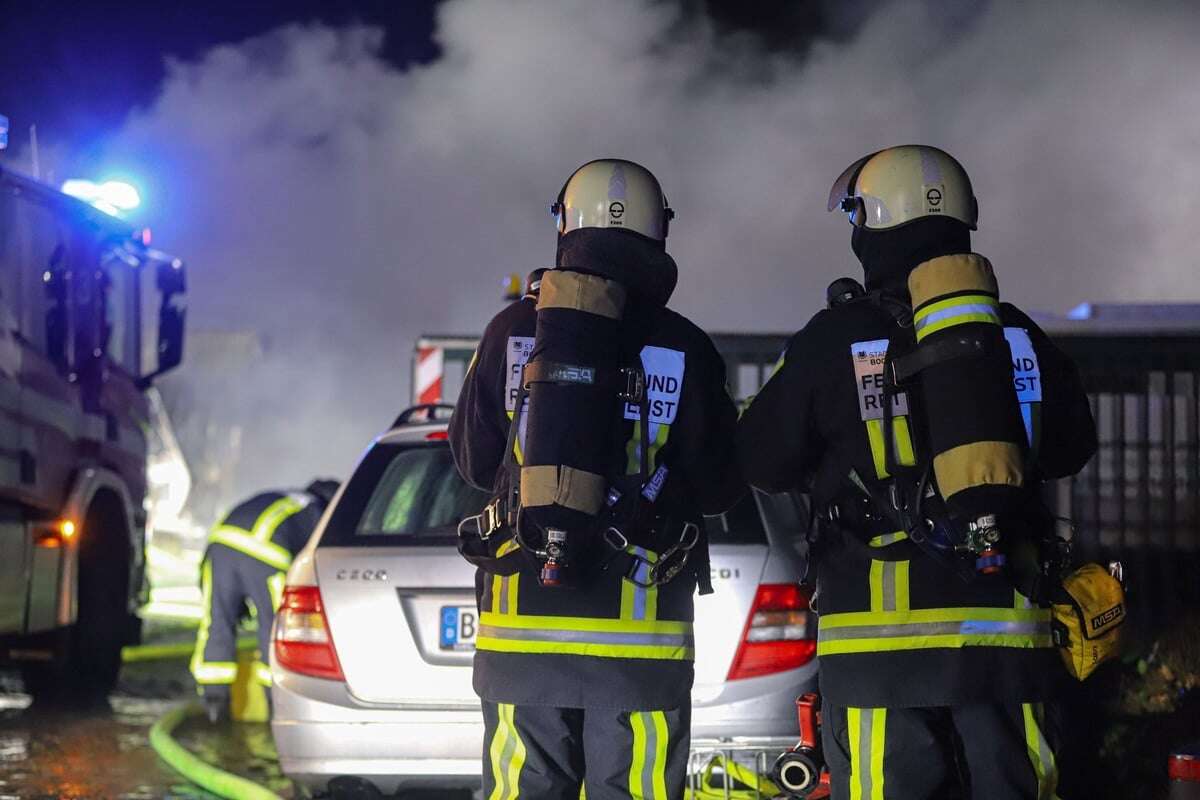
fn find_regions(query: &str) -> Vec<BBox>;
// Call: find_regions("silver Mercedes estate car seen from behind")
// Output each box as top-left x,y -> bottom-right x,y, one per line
271,408 -> 816,794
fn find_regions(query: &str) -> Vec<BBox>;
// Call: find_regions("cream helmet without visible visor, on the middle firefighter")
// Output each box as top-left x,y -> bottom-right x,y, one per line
550,158 -> 674,241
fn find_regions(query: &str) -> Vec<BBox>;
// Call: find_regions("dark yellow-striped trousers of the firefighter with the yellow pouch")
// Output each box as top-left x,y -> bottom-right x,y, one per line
821,703 -> 1058,800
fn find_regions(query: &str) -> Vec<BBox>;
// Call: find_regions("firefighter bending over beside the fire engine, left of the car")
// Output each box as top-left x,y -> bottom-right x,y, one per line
191,480 -> 337,722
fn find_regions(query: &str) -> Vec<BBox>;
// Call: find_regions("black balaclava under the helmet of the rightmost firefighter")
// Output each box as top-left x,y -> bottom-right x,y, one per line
850,217 -> 971,294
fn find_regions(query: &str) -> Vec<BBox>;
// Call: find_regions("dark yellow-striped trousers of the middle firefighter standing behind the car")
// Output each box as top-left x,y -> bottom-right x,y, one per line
484,700 -> 691,800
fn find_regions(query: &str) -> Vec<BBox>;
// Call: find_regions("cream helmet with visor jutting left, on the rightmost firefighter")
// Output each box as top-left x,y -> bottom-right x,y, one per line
829,144 -> 979,230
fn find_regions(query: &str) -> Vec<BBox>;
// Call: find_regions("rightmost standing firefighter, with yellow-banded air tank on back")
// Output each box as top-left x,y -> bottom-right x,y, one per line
738,145 -> 1096,800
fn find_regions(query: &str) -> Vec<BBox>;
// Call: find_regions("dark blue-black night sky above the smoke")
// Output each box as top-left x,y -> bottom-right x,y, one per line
0,0 -> 854,162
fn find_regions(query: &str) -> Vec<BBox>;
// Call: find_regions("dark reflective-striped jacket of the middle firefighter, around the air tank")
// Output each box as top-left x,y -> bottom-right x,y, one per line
449,278 -> 744,711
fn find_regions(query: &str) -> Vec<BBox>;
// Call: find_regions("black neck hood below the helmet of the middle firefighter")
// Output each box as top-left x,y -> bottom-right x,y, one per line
554,228 -> 679,307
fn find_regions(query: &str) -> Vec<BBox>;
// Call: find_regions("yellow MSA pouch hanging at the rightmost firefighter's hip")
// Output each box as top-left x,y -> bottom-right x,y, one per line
1054,564 -> 1126,680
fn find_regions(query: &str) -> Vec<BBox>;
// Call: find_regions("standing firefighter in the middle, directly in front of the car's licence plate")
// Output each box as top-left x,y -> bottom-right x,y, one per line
450,158 -> 743,800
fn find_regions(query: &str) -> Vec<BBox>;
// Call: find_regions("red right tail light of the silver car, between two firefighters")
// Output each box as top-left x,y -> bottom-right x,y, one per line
728,583 -> 817,680
